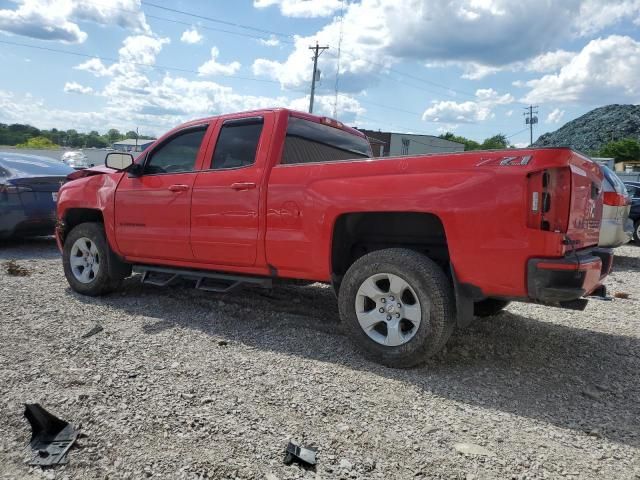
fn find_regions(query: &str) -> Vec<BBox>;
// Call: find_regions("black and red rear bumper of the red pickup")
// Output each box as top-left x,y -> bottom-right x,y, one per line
527,248 -> 613,303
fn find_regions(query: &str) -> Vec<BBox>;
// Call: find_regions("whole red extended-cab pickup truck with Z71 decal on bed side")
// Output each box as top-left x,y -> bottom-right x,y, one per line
56,109 -> 613,367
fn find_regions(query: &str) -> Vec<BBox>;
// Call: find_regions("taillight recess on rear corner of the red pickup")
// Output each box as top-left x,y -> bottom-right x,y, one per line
527,168 -> 571,233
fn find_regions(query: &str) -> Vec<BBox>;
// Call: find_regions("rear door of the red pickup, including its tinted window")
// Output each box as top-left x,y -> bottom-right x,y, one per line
191,115 -> 274,266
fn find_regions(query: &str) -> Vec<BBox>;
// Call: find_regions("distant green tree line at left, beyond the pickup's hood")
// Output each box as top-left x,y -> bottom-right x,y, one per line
0,123 -> 154,148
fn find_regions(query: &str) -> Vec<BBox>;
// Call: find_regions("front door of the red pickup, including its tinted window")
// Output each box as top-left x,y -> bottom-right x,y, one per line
115,125 -> 207,260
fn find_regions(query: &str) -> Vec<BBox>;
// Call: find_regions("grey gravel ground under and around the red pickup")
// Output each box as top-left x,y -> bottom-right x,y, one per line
0,239 -> 640,480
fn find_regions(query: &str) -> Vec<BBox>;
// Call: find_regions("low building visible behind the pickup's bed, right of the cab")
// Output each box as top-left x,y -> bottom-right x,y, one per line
358,128 -> 464,157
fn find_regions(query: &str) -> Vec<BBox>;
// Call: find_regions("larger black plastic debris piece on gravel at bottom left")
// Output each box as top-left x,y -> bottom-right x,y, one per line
24,403 -> 78,467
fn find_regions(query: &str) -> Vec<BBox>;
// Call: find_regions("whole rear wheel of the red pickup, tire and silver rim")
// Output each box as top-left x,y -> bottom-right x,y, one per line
338,248 -> 455,368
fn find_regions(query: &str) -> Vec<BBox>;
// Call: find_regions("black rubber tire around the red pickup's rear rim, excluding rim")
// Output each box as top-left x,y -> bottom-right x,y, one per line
338,248 -> 456,368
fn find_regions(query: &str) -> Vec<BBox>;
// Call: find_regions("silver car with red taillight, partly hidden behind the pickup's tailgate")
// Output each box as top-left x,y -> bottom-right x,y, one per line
598,165 -> 633,248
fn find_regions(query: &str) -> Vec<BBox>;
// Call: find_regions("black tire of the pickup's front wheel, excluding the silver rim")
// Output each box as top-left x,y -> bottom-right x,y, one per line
62,223 -> 123,297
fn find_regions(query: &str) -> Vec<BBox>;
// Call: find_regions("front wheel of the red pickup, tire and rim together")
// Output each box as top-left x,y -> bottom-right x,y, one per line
62,223 -> 121,297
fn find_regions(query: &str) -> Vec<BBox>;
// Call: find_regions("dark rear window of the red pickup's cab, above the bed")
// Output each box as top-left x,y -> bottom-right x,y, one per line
281,116 -> 371,164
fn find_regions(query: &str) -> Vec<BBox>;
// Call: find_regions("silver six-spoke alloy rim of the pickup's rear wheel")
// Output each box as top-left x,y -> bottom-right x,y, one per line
355,273 -> 422,347
